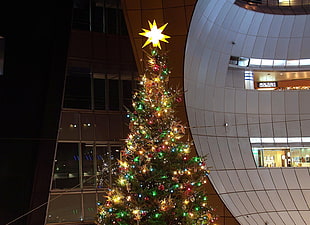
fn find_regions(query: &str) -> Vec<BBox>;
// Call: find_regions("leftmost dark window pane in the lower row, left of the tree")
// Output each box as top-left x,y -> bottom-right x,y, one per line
53,143 -> 80,189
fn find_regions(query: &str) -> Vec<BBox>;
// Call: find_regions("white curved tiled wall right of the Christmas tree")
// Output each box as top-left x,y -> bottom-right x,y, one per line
184,0 -> 310,225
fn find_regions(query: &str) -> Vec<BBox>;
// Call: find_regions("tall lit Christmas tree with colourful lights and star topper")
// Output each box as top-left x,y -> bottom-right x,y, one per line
97,21 -> 217,225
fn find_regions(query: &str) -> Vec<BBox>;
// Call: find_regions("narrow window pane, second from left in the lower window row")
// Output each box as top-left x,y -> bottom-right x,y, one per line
82,144 -> 96,187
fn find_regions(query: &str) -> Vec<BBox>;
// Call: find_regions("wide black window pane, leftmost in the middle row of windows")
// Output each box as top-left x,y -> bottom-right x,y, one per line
64,67 -> 91,109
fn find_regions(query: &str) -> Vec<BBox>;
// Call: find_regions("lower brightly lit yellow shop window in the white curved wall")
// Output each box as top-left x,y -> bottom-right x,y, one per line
252,147 -> 310,167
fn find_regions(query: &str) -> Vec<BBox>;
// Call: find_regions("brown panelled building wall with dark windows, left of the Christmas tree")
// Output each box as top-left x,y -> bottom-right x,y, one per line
46,0 -> 137,224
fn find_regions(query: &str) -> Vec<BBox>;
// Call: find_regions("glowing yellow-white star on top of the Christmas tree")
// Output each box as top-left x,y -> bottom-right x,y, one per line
139,20 -> 170,49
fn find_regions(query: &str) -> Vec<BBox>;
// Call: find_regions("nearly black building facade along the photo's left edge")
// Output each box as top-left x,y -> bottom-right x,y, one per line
0,1 -> 72,224
